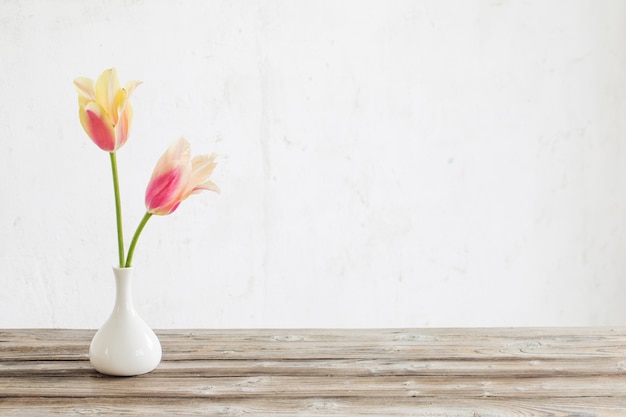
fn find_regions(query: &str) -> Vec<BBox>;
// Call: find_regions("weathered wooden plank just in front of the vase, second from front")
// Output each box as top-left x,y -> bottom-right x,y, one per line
0,375 -> 626,398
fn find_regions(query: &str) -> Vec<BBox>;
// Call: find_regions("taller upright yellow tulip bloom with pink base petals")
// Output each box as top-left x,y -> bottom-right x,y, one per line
74,68 -> 141,152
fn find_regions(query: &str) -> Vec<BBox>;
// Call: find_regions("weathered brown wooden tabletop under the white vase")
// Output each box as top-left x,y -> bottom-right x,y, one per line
0,328 -> 626,417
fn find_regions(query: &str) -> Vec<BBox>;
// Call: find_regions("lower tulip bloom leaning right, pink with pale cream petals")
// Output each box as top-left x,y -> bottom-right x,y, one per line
145,137 -> 219,215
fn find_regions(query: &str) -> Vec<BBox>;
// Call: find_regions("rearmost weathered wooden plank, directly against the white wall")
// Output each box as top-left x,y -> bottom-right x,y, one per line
0,329 -> 626,361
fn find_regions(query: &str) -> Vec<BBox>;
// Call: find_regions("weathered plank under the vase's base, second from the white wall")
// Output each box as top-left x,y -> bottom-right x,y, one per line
0,357 -> 626,378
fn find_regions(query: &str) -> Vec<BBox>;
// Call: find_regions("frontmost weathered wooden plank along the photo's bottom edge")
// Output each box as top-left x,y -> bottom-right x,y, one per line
0,398 -> 626,417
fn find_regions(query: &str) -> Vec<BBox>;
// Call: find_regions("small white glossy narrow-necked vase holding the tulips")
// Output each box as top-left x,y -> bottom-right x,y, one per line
89,268 -> 161,376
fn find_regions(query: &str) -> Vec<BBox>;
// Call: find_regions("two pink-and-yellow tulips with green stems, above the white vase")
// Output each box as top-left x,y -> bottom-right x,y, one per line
74,68 -> 219,268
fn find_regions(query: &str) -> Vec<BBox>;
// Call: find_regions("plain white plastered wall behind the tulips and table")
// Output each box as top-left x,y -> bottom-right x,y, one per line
0,0 -> 626,328
